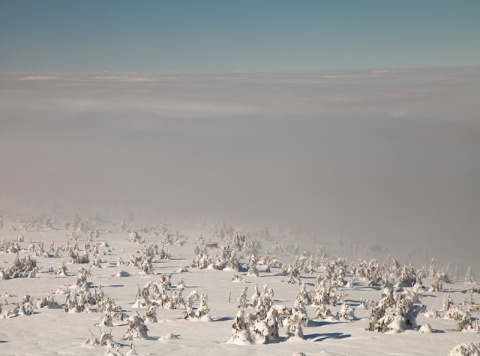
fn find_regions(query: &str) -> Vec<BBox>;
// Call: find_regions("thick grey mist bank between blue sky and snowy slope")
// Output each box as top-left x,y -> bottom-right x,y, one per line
0,68 -> 480,268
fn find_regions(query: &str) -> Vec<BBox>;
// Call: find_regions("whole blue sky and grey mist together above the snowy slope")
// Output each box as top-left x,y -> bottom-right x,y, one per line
0,0 -> 480,272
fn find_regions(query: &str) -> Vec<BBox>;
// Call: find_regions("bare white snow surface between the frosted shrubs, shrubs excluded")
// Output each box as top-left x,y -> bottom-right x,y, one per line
0,210 -> 480,355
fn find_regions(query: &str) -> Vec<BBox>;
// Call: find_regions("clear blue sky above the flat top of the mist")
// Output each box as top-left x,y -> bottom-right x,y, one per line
0,0 -> 480,72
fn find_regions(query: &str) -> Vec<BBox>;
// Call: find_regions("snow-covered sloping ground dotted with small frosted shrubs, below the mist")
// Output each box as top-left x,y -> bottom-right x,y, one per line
0,212 -> 480,355
